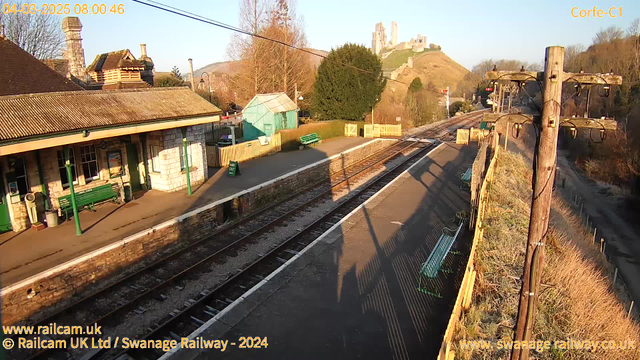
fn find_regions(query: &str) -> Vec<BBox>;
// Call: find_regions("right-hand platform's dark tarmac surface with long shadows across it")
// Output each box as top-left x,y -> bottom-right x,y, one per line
192,143 -> 477,359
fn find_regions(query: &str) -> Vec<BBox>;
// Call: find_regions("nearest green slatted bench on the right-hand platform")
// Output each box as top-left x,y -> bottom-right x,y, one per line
418,221 -> 464,298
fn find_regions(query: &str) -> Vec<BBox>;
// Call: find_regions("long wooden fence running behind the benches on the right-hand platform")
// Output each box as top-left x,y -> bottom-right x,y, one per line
438,131 -> 500,360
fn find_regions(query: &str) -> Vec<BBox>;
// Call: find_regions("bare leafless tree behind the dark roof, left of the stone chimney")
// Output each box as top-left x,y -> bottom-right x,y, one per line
0,0 -> 64,60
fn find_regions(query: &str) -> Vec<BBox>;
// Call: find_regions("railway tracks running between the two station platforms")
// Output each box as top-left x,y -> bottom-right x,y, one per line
12,110 -> 477,359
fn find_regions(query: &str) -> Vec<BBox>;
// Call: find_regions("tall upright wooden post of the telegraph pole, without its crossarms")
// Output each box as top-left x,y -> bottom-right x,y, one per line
511,46 -> 564,360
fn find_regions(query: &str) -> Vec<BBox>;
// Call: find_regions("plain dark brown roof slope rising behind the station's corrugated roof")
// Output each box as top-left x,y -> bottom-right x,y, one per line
0,38 -> 83,96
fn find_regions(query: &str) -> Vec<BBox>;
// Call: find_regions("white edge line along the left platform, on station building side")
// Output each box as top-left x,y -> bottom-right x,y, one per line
0,139 -> 390,296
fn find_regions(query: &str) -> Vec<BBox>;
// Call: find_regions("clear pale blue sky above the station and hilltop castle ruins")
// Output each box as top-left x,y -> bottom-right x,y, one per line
48,0 -> 640,74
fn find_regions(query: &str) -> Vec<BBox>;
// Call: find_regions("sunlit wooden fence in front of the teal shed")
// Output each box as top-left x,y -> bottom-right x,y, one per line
207,134 -> 282,167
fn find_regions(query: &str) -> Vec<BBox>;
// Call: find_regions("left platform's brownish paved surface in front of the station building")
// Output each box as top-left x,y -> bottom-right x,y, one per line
0,137 -> 371,289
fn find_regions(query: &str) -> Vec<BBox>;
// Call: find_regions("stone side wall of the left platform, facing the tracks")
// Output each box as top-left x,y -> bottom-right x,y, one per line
1,140 -> 394,325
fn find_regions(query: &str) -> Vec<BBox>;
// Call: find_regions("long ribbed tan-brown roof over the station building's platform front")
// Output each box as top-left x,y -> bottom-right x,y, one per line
0,87 -> 221,141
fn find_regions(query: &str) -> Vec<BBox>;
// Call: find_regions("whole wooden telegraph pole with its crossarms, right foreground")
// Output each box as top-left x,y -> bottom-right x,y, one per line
484,46 -> 622,360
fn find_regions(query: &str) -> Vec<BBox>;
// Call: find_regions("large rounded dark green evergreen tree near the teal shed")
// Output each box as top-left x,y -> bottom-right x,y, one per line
312,44 -> 387,120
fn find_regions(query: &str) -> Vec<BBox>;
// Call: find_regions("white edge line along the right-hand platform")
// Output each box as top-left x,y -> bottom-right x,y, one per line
158,143 -> 445,360
